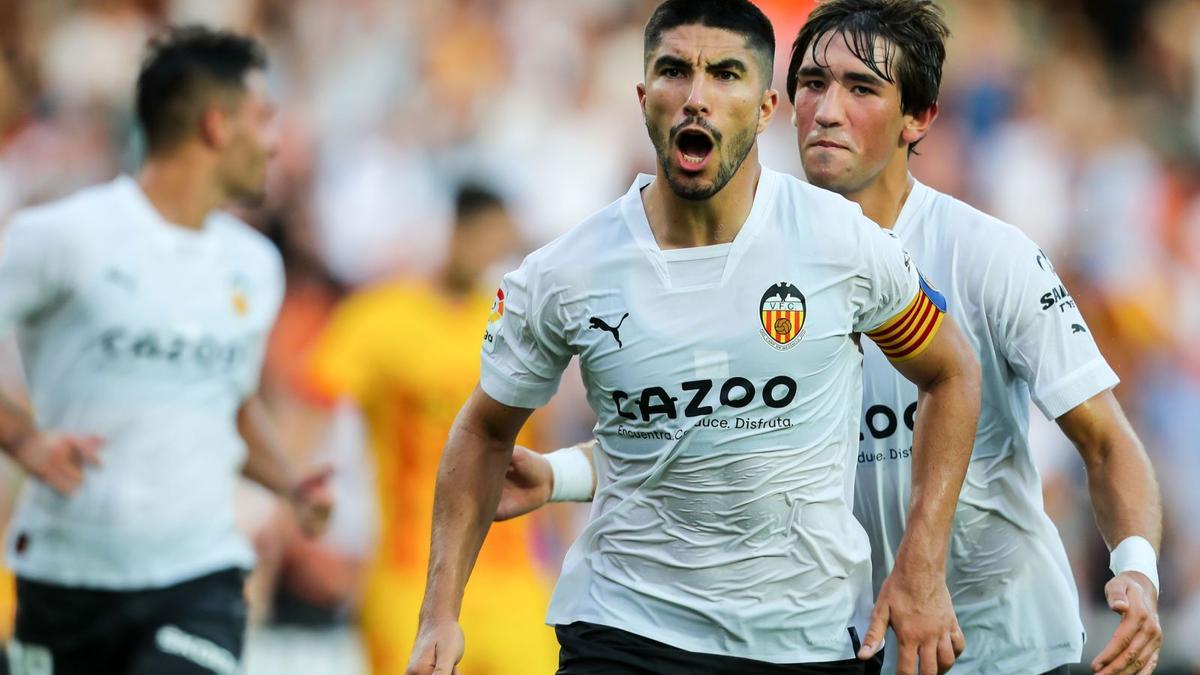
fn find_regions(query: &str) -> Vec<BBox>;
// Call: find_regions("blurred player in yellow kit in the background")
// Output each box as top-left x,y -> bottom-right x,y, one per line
308,181 -> 558,675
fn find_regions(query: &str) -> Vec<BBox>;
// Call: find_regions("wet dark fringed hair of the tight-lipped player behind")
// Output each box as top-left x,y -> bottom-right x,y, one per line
787,0 -> 950,141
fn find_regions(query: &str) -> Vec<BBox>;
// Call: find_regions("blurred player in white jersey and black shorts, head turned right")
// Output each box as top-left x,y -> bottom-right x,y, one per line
0,28 -> 329,675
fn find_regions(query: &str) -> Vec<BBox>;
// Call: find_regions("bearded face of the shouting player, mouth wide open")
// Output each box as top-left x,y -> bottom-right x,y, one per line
637,25 -> 778,199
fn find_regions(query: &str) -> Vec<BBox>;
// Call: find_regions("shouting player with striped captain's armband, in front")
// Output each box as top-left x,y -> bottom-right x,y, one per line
409,0 -> 979,675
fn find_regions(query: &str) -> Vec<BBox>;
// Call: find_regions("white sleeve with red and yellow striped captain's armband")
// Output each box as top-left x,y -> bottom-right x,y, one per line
856,227 -> 946,362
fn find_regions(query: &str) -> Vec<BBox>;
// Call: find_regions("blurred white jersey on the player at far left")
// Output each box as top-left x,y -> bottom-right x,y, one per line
0,177 -> 283,590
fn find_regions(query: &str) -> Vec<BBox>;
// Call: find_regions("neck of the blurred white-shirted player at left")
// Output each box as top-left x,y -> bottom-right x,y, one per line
138,150 -> 224,229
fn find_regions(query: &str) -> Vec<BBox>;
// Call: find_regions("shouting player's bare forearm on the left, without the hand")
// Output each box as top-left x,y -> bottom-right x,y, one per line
421,414 -> 514,620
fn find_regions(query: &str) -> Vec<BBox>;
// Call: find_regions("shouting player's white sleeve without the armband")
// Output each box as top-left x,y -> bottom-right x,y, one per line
480,258 -> 571,408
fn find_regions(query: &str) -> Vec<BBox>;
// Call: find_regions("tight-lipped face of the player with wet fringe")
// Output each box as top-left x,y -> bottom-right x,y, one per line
792,32 -> 936,195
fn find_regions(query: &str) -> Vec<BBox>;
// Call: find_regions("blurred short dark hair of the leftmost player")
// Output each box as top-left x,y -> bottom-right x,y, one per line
137,25 -> 266,154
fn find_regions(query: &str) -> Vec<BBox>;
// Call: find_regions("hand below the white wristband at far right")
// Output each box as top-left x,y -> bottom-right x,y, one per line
1092,572 -> 1163,675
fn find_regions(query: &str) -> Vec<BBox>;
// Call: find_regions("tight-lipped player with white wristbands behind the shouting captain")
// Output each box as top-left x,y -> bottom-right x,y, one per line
499,0 -> 1162,675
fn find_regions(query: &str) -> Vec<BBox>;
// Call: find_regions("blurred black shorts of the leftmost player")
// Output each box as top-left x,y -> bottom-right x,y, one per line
8,569 -> 246,675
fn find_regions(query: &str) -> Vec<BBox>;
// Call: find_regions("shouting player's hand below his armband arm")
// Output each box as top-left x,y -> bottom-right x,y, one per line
858,571 -> 966,675
